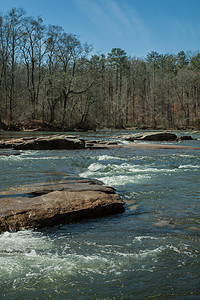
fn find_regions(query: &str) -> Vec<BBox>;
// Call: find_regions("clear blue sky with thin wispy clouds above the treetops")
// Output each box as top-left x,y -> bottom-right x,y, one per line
0,0 -> 200,57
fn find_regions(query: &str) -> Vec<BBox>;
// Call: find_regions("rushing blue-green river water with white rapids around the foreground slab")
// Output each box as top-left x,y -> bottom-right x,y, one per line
0,132 -> 200,300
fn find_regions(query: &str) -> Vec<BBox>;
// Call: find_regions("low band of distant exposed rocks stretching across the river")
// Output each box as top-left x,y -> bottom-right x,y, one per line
0,132 -> 199,155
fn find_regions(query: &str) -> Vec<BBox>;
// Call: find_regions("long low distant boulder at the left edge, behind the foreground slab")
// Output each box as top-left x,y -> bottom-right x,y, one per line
0,135 -> 85,150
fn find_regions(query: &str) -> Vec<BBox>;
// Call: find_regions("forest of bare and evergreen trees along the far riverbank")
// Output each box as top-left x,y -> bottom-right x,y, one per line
0,8 -> 200,130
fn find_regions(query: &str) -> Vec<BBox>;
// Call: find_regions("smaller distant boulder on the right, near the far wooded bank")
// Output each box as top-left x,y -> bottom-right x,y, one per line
122,132 -> 177,142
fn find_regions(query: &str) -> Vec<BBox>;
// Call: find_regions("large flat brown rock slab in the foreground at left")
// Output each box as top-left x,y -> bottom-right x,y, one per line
0,180 -> 124,232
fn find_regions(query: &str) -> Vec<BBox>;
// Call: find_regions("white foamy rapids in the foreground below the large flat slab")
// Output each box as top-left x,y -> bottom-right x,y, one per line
0,231 -> 195,281
